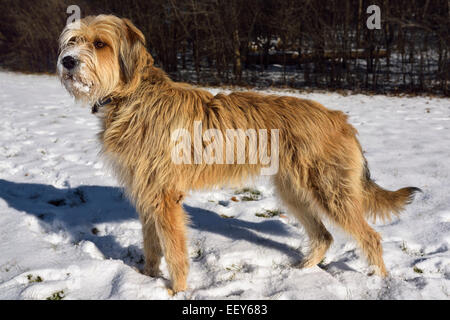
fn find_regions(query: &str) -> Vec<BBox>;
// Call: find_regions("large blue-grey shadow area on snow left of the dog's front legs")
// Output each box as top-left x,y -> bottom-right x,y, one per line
0,179 -> 143,268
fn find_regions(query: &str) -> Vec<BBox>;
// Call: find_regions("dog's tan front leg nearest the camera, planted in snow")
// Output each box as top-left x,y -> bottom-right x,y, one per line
153,192 -> 189,293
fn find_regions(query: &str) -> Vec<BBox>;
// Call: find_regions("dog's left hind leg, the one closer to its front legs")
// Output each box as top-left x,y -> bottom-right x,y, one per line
276,179 -> 333,268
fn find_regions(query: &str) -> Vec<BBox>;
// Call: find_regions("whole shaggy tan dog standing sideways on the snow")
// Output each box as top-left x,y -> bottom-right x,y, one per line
58,15 -> 419,292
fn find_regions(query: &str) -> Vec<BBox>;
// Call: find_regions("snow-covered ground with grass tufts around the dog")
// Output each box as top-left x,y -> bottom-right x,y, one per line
0,72 -> 450,299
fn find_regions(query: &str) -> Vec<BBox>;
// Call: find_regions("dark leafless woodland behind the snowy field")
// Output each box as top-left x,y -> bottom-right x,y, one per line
0,0 -> 450,96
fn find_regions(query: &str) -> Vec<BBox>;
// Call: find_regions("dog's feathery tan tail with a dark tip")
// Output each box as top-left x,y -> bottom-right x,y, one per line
363,162 -> 422,221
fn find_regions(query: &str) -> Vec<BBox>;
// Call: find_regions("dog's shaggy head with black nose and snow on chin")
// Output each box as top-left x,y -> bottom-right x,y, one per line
57,15 -> 153,103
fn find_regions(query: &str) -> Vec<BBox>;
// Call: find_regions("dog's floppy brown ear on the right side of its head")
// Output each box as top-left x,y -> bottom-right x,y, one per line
119,19 -> 153,83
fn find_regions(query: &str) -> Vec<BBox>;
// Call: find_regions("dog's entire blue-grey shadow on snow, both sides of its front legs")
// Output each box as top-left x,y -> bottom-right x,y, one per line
0,179 -> 301,269
